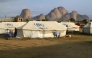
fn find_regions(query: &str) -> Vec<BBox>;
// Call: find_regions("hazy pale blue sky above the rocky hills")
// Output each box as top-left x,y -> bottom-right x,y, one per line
0,0 -> 92,18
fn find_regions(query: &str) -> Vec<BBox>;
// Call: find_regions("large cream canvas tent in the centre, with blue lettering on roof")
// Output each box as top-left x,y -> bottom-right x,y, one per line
17,21 -> 67,38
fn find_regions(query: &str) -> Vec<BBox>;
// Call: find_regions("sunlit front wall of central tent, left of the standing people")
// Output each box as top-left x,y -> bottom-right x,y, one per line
23,30 -> 54,38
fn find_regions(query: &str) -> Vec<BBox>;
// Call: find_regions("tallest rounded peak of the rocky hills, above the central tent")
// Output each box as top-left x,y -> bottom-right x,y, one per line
47,7 -> 67,21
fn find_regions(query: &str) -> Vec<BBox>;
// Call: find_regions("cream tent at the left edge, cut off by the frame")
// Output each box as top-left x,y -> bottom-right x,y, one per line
0,22 -> 26,34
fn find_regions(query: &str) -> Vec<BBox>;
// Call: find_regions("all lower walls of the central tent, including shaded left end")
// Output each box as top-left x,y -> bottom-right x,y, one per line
17,29 -> 66,38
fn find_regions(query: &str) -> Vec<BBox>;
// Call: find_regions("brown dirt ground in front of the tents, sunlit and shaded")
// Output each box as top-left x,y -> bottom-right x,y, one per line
0,35 -> 92,58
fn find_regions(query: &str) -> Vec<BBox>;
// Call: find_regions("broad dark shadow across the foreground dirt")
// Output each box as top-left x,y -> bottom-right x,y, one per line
0,41 -> 92,58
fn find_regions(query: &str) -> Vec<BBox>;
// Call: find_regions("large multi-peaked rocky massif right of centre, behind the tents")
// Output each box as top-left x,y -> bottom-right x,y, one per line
46,7 -> 89,21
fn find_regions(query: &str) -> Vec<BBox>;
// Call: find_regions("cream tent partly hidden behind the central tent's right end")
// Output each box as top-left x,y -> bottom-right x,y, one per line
61,22 -> 79,31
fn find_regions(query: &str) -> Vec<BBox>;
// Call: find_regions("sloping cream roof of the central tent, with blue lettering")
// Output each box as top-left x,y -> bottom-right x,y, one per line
19,21 -> 67,30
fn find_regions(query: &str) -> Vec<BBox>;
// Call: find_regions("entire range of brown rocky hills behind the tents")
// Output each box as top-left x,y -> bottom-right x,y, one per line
20,7 -> 89,21
